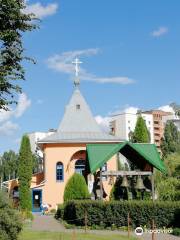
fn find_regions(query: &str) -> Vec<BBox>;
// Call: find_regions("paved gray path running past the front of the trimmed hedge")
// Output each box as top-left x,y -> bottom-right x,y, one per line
30,214 -> 180,240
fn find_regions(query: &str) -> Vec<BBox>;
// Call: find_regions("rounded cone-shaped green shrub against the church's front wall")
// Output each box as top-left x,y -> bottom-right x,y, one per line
64,173 -> 89,202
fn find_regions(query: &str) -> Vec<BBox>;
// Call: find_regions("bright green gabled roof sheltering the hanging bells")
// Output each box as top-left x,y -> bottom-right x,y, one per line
87,142 -> 166,173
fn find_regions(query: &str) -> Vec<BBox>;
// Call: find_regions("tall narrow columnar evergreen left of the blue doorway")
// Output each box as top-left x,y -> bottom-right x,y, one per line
18,135 -> 33,211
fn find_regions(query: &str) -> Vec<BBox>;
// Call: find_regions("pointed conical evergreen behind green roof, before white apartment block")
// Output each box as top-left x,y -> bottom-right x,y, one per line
131,115 -> 150,143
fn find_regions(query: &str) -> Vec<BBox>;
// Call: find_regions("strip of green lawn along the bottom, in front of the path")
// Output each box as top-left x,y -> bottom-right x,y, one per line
19,231 -> 137,240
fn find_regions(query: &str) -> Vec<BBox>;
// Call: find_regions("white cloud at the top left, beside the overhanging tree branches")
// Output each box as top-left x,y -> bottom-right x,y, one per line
23,2 -> 58,19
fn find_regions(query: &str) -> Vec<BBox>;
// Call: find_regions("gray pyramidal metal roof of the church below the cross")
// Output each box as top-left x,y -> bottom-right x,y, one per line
39,87 -> 120,143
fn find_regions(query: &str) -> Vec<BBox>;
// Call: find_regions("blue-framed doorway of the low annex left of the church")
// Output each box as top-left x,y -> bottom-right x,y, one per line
32,189 -> 42,212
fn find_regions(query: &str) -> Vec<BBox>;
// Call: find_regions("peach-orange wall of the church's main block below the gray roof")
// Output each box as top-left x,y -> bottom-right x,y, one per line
42,144 -> 117,208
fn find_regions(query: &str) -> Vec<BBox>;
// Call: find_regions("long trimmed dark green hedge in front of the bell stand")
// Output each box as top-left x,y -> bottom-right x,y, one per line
56,200 -> 180,228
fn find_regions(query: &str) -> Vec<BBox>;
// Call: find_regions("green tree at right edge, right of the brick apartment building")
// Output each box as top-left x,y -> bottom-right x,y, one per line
161,121 -> 180,157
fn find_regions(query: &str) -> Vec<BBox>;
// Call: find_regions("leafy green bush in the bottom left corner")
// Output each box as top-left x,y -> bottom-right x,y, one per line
0,192 -> 22,240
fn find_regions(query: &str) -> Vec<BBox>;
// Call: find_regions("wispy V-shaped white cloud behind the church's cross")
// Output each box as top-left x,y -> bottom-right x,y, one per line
47,48 -> 134,84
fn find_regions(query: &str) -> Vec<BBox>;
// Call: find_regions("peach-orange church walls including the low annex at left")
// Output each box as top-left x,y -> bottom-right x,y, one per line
8,144 -> 117,208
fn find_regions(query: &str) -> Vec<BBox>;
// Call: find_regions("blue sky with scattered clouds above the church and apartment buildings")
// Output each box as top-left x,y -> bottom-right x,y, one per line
0,0 -> 180,154
